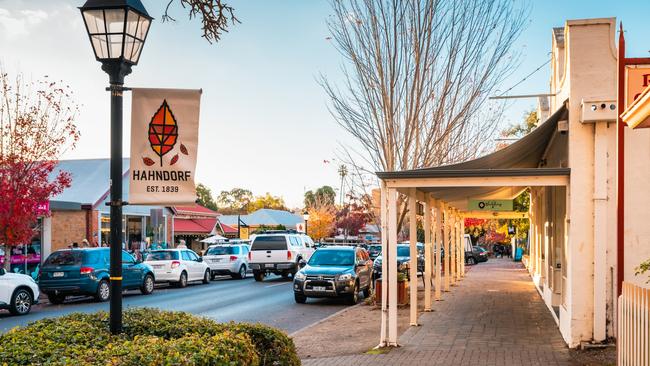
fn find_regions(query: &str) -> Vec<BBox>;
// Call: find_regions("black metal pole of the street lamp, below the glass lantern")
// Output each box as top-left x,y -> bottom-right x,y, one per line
102,61 -> 131,334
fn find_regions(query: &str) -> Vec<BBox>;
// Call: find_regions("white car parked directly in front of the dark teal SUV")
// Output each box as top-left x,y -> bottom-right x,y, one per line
144,249 -> 211,287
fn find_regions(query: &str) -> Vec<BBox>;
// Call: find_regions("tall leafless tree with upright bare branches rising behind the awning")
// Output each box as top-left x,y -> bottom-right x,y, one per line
321,0 -> 527,229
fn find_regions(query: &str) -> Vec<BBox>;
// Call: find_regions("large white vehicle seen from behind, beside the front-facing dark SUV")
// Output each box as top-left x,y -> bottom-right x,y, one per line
248,231 -> 320,281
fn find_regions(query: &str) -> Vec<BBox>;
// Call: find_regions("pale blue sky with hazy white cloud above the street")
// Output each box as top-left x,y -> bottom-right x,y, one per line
0,0 -> 650,207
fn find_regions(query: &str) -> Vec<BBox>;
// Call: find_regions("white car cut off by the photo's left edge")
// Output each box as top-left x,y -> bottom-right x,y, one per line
0,268 -> 39,315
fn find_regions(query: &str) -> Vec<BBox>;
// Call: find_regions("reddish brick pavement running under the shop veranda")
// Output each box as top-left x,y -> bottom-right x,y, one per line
303,259 -> 573,366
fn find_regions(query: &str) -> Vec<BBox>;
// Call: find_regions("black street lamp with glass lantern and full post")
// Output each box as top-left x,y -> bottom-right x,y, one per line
79,0 -> 152,334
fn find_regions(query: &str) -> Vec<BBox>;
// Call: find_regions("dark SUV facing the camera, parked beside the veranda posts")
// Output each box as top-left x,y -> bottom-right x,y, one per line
293,246 -> 372,304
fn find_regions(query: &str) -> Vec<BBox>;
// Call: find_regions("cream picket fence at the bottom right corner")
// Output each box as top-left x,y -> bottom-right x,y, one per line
616,282 -> 650,366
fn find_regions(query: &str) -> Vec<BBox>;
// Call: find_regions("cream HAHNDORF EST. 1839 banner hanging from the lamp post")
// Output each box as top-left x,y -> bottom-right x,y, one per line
128,88 -> 201,205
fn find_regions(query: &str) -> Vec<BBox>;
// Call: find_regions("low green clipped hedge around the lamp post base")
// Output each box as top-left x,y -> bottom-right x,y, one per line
0,308 -> 300,366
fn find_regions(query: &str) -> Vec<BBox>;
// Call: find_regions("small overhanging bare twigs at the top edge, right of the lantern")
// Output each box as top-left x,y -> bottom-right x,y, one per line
162,0 -> 239,43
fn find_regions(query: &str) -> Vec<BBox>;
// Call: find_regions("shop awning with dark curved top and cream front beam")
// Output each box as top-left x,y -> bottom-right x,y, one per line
377,104 -> 570,209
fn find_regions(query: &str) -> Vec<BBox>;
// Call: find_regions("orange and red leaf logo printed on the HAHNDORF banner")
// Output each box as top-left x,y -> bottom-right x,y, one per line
143,100 -> 178,166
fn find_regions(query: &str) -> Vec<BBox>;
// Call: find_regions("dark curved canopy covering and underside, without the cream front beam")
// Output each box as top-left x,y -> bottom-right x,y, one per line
377,104 -> 569,209
